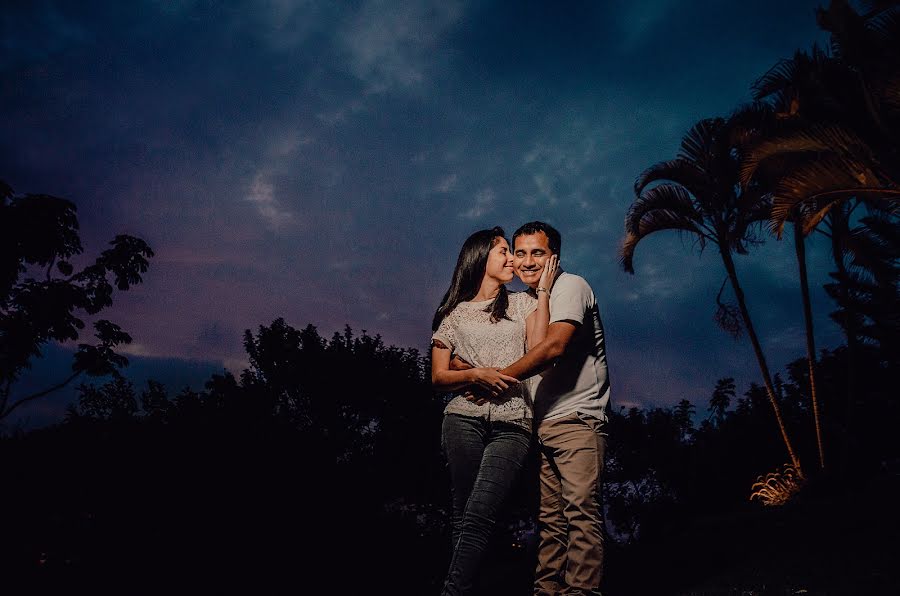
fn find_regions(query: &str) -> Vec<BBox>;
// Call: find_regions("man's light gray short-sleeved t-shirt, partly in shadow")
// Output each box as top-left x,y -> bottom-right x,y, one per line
531,272 -> 610,422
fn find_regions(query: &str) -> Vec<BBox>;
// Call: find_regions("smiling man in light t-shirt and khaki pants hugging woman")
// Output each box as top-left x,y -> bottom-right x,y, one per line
501,221 -> 609,595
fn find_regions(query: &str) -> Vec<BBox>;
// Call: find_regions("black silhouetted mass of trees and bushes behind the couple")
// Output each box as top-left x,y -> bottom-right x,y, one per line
0,320 -> 900,594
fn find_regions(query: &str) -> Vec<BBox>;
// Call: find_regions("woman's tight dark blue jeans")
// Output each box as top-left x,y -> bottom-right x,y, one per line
441,414 -> 531,596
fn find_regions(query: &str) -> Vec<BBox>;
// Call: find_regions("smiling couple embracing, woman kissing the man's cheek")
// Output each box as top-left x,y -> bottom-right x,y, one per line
431,221 -> 609,595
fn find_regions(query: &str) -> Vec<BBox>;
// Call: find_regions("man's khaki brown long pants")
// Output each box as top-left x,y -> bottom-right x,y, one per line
534,413 -> 606,595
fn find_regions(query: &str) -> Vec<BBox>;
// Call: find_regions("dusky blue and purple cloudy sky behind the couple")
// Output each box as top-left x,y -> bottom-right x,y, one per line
0,0 -> 841,428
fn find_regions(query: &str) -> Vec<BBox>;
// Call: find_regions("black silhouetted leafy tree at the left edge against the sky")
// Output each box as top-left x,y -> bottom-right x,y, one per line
0,181 -> 153,421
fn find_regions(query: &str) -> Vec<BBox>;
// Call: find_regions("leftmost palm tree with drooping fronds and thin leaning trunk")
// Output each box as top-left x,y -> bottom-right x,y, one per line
621,118 -> 803,480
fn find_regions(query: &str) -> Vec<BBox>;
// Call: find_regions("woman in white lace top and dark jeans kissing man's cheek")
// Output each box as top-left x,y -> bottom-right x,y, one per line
431,228 -> 557,595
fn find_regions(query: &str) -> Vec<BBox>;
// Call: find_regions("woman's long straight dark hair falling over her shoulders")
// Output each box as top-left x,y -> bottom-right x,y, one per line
431,227 -> 509,331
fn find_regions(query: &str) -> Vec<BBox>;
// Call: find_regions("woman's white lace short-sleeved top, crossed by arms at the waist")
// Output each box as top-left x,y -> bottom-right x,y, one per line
431,292 -> 537,431
